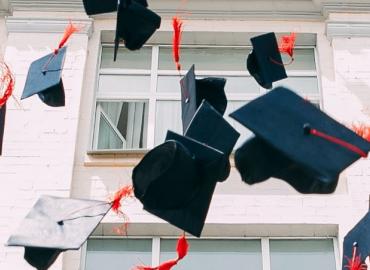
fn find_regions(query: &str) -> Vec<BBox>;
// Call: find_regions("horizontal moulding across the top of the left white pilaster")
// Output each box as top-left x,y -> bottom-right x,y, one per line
6,17 -> 93,37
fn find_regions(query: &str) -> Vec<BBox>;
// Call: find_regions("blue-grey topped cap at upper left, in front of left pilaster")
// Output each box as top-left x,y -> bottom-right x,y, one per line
21,47 -> 67,107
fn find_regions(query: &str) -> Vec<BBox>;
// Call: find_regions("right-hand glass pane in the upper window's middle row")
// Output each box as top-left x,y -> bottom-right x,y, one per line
274,77 -> 319,97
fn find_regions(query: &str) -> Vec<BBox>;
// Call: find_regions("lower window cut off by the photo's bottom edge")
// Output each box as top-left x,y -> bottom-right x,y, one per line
84,238 -> 336,270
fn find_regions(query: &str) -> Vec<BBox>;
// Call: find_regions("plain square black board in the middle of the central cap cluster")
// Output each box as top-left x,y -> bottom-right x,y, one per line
185,100 -> 240,158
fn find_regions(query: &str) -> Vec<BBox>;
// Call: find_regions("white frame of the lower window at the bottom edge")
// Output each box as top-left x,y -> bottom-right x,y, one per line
79,236 -> 341,270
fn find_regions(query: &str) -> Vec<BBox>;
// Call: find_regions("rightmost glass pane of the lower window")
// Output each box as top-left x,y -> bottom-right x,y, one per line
270,239 -> 335,270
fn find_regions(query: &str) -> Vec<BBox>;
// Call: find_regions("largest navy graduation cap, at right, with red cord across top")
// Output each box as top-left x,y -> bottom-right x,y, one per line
230,87 -> 370,193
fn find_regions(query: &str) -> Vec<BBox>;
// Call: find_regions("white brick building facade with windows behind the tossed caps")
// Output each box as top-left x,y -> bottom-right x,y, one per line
0,0 -> 370,270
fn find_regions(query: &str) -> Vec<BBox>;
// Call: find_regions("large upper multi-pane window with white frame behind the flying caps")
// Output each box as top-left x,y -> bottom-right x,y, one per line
93,45 -> 320,150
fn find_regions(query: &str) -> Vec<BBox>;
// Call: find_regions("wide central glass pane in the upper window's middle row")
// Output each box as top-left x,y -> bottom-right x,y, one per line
157,76 -> 260,94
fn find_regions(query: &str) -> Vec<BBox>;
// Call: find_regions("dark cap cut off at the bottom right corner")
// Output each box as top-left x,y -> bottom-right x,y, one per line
342,212 -> 370,270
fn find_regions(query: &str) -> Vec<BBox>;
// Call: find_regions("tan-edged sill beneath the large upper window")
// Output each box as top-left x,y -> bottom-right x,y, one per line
84,149 -> 235,167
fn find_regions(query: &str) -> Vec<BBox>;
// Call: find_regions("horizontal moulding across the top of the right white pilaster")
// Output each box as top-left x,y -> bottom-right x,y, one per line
326,21 -> 370,40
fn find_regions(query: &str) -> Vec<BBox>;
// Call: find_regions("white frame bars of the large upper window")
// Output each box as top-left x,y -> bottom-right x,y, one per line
88,42 -> 323,154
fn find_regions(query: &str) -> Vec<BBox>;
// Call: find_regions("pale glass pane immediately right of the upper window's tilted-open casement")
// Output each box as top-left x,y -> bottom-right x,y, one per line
155,100 -> 182,145
